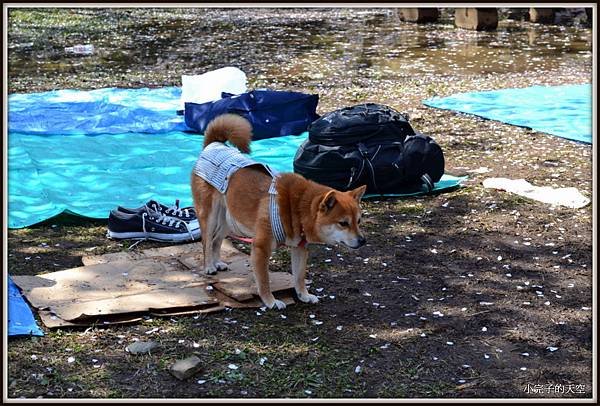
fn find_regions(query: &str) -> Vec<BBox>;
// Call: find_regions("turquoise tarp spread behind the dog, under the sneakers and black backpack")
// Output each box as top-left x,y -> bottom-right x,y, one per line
8,132 -> 462,228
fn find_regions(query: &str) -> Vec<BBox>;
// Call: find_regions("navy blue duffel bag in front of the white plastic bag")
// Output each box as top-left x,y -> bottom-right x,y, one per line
184,90 -> 319,140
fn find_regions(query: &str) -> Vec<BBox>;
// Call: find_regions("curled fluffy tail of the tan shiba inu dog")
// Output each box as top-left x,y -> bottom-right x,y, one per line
204,114 -> 252,154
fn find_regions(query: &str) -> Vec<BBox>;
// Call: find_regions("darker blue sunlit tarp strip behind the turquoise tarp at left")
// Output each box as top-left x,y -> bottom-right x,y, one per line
8,87 -> 188,135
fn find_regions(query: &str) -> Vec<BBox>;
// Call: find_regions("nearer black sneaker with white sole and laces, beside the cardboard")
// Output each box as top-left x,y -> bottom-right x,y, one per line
107,207 -> 200,242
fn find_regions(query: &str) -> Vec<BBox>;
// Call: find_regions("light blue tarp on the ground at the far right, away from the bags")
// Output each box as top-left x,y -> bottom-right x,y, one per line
423,84 -> 592,143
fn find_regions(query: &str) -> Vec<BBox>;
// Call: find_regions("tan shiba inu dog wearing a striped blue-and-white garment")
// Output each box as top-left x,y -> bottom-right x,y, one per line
192,114 -> 366,309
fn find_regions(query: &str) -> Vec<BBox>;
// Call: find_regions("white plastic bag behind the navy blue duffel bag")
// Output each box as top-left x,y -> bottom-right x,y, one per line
181,66 -> 247,110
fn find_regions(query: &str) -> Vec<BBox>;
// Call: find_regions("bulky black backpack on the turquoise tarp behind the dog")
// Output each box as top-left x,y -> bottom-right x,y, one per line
294,103 -> 444,194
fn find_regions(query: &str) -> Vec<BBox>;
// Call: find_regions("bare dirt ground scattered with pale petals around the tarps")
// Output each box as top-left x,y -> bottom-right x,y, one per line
7,10 -> 593,398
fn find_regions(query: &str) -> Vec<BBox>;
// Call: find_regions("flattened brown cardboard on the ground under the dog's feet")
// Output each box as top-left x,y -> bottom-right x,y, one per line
13,240 -> 294,328
